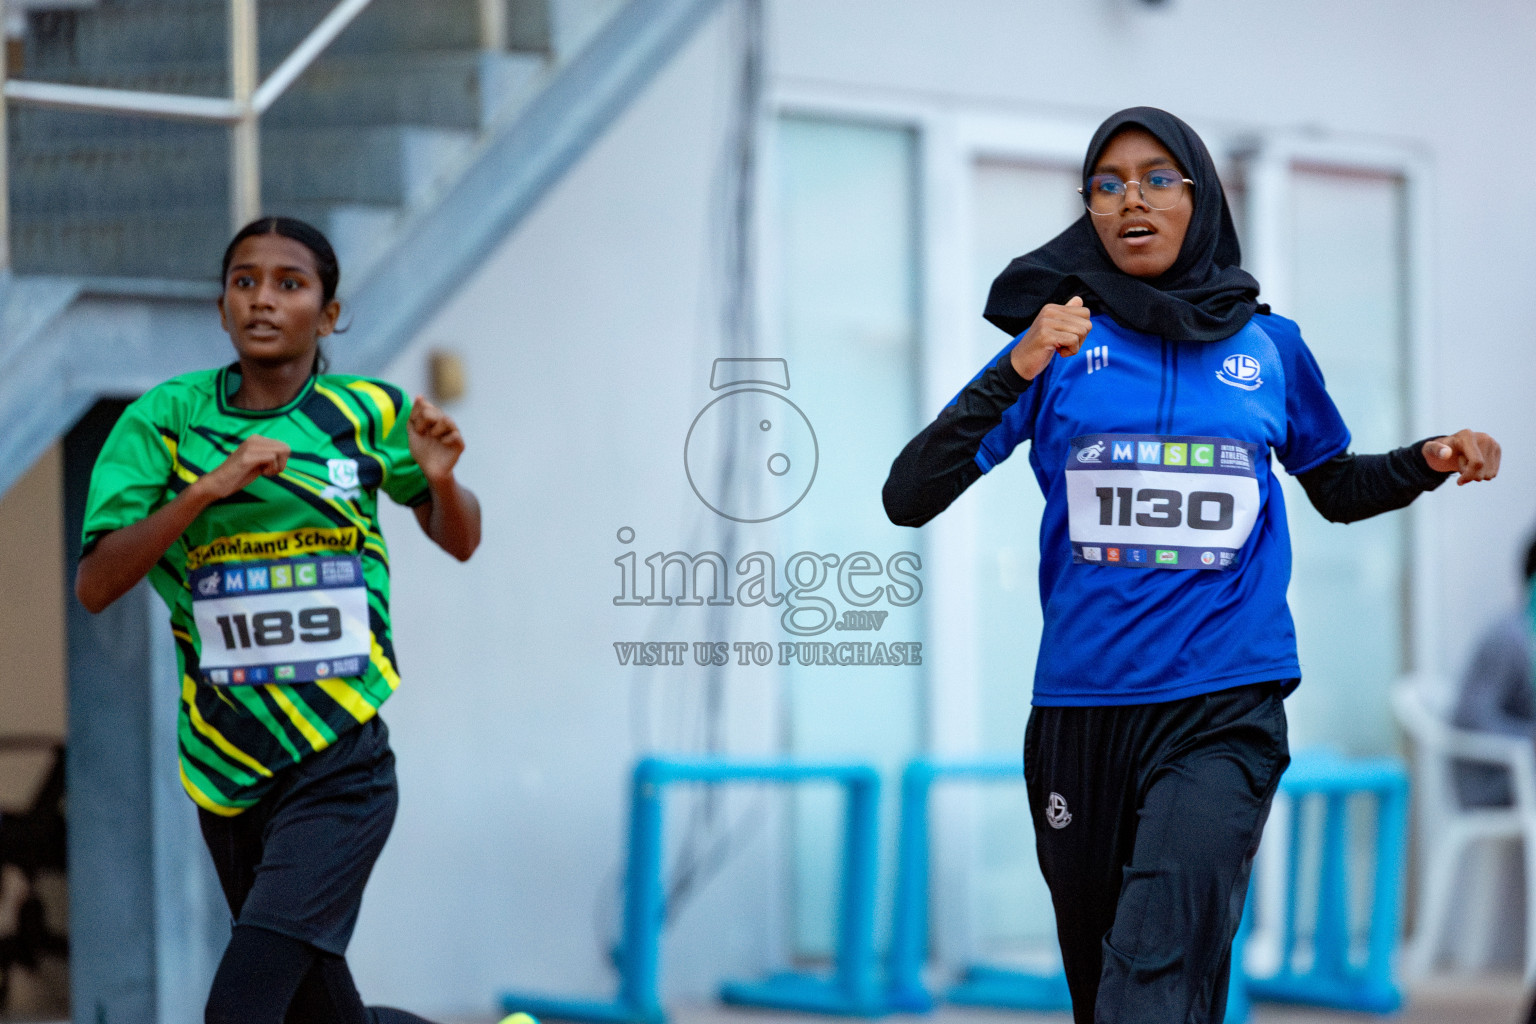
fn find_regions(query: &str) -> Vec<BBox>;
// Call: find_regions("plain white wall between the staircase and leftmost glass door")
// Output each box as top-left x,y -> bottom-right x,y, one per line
350,4 -> 777,1013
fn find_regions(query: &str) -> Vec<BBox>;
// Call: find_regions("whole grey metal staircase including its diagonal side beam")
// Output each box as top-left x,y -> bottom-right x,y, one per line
0,0 -> 719,494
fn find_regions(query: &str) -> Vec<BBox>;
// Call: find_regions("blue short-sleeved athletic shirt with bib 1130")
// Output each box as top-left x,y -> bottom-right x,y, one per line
975,313 -> 1350,706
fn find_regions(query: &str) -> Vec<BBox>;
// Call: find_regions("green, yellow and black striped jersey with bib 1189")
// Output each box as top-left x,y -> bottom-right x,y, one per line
84,365 -> 429,815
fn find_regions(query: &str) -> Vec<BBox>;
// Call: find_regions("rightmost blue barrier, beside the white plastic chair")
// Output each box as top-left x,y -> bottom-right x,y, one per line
1249,752 -> 1409,1013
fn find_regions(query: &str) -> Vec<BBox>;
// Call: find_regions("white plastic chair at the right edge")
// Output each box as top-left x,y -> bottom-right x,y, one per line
1392,676 -> 1536,987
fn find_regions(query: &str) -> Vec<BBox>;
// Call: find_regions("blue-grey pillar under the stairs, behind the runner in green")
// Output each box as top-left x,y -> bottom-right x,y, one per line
65,401 -> 229,1024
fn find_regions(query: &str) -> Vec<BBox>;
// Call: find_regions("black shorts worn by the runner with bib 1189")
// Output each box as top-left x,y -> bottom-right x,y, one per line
198,715 -> 398,956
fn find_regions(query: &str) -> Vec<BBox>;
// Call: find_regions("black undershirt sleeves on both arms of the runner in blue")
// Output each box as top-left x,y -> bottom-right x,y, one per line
882,359 -> 1450,527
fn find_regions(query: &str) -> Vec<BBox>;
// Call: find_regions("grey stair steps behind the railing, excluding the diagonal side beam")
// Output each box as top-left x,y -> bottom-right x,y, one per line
11,0 -> 551,279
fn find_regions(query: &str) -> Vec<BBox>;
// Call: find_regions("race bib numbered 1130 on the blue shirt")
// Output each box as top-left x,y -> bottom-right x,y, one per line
1066,434 -> 1260,570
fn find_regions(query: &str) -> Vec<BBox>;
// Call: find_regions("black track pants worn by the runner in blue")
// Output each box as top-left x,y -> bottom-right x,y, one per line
1025,682 -> 1290,1024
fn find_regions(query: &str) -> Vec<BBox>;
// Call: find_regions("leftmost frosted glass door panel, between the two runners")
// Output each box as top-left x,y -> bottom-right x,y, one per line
773,117 -> 925,958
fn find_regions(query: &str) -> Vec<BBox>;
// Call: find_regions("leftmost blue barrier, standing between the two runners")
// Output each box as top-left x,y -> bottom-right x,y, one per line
501,757 -> 885,1024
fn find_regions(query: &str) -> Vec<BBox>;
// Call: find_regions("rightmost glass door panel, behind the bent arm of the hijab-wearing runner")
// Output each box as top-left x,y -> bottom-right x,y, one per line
1278,164 -> 1413,754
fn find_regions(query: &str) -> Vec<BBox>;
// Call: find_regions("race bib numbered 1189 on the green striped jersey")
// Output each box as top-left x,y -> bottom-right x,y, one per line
192,554 -> 373,686
